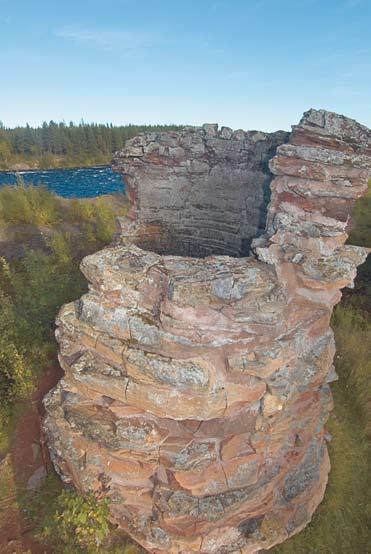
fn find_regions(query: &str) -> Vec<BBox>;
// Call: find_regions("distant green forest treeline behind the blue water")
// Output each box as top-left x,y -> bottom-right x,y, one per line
0,121 -> 184,169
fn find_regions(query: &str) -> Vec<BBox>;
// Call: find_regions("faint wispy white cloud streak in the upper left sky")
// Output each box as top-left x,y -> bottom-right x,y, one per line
55,25 -> 152,53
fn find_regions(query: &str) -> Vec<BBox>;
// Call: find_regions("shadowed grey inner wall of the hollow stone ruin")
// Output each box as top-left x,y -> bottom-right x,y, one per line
117,126 -> 288,258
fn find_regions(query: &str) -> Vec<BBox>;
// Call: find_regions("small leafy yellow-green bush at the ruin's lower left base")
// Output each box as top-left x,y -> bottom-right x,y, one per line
41,491 -> 110,554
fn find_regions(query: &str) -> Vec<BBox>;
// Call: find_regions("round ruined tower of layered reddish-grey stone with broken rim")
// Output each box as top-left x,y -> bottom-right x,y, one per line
45,110 -> 371,554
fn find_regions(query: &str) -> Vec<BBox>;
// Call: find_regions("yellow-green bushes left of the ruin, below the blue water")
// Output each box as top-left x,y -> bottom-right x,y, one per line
0,183 -> 124,440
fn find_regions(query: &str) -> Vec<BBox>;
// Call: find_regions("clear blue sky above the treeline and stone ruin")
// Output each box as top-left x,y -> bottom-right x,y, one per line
0,0 -> 371,130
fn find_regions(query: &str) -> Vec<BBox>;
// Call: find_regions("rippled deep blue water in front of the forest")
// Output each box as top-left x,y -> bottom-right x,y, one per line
0,167 -> 124,198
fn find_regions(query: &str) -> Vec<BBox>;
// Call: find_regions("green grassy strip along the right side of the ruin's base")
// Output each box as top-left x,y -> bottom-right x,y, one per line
272,299 -> 371,554
